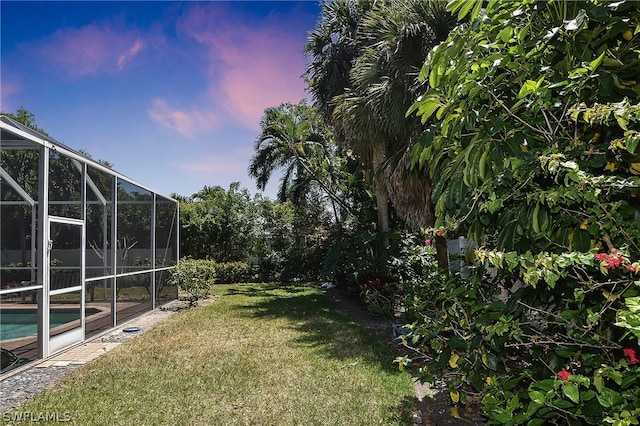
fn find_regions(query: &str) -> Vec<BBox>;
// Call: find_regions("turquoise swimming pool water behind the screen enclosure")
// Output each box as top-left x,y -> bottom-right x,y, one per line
0,308 -> 100,340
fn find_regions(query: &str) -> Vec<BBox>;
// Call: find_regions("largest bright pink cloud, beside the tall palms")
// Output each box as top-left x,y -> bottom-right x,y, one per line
178,3 -> 305,129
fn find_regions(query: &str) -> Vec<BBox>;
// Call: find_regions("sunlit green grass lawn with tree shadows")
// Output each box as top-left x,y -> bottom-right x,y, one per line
7,284 -> 416,426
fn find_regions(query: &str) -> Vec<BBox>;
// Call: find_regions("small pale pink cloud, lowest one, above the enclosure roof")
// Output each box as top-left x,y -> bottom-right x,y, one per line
147,98 -> 219,137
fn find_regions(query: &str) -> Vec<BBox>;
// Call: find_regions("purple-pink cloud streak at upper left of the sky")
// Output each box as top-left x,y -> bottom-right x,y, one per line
32,23 -> 145,77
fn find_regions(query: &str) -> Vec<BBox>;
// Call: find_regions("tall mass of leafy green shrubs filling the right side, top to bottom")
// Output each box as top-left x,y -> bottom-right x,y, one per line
401,0 -> 640,425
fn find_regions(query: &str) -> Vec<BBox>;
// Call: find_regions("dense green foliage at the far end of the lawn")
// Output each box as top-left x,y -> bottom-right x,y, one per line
178,183 -> 334,282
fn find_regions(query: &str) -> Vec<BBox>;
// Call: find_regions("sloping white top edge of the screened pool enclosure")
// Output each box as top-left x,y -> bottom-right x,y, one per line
0,115 -> 176,201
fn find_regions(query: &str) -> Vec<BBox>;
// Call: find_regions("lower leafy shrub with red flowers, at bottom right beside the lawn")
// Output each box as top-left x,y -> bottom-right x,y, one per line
398,240 -> 640,424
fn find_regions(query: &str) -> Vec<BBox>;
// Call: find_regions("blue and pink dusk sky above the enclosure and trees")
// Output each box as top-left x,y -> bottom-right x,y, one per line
0,0 -> 320,198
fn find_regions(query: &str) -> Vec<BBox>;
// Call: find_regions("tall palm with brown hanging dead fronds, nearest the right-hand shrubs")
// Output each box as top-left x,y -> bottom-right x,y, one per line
356,0 -> 456,268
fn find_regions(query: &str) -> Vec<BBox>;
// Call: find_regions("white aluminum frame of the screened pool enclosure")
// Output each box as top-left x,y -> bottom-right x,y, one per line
0,116 -> 180,366
